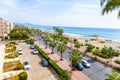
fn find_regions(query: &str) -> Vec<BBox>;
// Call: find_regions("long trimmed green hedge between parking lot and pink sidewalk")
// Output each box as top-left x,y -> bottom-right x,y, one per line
35,45 -> 71,80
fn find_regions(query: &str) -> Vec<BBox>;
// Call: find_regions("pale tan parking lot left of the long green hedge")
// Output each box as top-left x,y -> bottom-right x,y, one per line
17,43 -> 57,80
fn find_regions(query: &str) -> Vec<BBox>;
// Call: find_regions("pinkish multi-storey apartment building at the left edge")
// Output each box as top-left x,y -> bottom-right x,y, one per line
0,18 -> 14,38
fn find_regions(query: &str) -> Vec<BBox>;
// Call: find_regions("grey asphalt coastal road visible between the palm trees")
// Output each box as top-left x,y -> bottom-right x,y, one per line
35,35 -> 111,80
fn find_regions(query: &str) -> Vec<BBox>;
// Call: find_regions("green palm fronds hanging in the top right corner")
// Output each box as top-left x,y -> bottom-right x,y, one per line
101,0 -> 120,17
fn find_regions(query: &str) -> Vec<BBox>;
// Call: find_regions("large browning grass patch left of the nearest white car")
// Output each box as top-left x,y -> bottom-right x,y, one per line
3,61 -> 24,72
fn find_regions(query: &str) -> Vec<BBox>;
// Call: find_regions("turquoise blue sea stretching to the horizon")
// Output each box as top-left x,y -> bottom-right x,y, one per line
24,24 -> 120,42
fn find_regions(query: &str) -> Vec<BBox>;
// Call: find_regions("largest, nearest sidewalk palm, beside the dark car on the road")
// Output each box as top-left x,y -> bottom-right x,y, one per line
70,50 -> 82,70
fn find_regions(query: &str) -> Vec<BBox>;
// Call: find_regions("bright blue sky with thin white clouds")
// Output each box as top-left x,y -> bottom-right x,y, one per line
0,0 -> 120,28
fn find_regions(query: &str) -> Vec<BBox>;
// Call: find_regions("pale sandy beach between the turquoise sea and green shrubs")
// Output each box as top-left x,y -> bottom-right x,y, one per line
64,33 -> 120,51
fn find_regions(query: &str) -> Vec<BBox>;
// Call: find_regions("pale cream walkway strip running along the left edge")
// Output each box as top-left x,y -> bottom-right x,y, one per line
0,44 -> 5,80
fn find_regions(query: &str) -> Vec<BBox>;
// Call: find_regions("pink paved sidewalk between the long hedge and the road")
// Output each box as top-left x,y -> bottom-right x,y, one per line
35,41 -> 89,80
